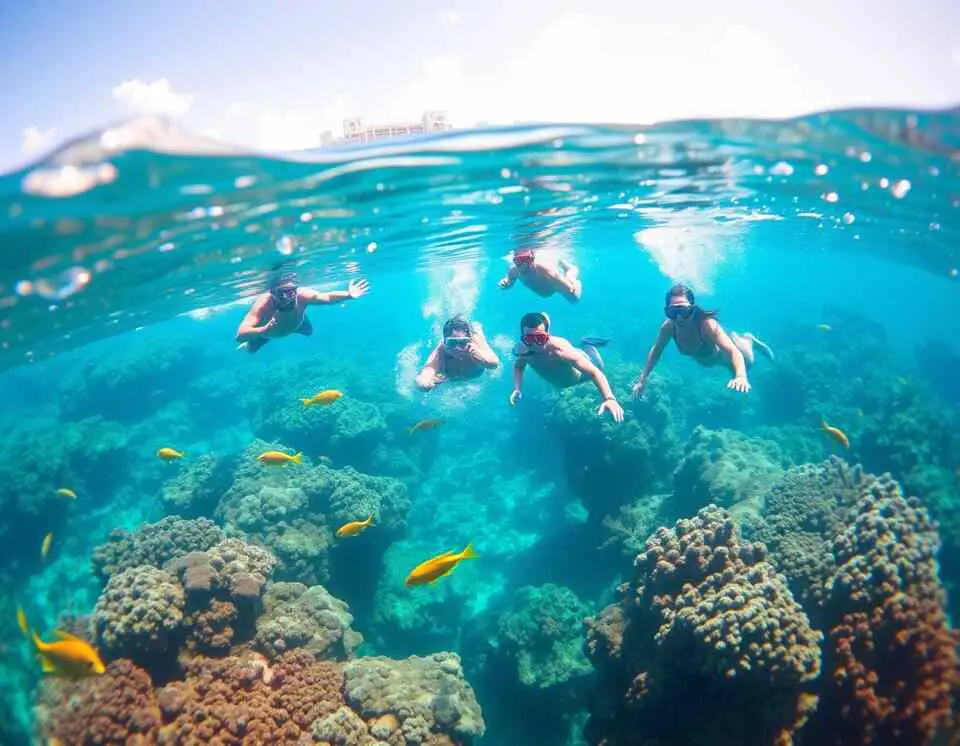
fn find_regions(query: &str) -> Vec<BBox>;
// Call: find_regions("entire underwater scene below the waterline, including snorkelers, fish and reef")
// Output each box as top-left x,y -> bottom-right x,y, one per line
0,110 -> 960,746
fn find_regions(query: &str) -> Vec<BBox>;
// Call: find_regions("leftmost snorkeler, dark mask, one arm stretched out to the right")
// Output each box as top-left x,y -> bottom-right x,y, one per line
237,272 -> 370,352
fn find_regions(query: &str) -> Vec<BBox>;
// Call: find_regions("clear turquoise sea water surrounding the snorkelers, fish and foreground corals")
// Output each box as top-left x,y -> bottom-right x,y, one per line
0,111 -> 960,744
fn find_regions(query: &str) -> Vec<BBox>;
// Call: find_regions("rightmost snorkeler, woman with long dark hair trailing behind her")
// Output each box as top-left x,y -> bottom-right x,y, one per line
633,285 -> 773,398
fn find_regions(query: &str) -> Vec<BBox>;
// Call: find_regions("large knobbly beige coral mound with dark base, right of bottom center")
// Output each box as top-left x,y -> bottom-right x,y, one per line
587,505 -> 821,746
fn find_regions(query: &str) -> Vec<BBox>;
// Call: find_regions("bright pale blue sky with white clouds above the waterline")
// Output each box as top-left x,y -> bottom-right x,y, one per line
0,0 -> 960,172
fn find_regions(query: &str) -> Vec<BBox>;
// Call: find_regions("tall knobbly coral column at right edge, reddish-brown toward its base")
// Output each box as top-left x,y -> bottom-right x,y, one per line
812,475 -> 960,745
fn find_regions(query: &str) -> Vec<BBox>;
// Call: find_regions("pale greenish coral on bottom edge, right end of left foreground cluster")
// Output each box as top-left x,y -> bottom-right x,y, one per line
343,653 -> 484,746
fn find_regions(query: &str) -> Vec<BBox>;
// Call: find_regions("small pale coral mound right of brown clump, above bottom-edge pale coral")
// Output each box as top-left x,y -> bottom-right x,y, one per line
254,582 -> 363,660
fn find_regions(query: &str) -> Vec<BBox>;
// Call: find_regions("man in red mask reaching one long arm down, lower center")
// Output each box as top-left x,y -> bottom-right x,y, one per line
510,312 -> 623,422
